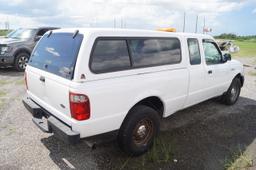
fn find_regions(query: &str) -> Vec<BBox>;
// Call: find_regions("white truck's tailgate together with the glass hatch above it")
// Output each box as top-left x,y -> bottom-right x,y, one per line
26,33 -> 83,125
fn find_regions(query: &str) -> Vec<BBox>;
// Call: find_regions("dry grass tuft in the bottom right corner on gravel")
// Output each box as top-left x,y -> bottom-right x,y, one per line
224,150 -> 254,170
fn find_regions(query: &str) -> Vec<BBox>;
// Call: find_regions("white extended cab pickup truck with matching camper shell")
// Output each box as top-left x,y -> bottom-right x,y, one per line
23,29 -> 244,155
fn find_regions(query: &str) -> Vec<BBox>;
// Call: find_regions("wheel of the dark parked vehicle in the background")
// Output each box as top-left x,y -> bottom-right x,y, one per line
14,52 -> 29,72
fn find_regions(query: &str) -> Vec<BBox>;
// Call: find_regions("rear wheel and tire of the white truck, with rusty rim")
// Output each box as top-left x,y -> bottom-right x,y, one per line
118,105 -> 160,156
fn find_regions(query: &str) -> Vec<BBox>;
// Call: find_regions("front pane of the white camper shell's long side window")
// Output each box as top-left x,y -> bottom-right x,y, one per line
128,38 -> 181,67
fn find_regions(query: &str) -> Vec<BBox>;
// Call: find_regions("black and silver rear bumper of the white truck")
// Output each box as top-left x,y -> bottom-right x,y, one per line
22,97 -> 80,144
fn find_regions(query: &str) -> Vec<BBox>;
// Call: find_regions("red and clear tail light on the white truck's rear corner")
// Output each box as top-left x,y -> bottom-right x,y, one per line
69,92 -> 90,120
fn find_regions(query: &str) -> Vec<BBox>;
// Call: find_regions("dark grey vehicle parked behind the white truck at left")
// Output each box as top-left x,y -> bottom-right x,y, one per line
0,27 -> 57,71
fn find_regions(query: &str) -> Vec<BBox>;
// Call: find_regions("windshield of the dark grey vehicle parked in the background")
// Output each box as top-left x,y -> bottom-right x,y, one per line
7,29 -> 36,39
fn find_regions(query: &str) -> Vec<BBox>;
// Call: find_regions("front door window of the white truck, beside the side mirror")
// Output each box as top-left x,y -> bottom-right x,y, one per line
203,40 -> 222,65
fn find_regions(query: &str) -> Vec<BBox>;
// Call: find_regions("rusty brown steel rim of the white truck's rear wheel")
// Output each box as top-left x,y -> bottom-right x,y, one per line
132,118 -> 154,146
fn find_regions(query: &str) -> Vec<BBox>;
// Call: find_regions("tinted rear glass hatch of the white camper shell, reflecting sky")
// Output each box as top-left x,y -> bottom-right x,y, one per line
28,33 -> 83,80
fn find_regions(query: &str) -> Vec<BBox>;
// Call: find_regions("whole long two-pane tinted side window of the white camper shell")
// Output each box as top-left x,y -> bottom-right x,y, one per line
90,37 -> 181,74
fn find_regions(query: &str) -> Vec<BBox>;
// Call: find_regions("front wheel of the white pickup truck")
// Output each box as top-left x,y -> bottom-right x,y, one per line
221,78 -> 242,105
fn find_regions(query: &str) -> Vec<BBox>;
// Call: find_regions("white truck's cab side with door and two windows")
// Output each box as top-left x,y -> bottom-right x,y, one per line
185,38 -> 230,107
